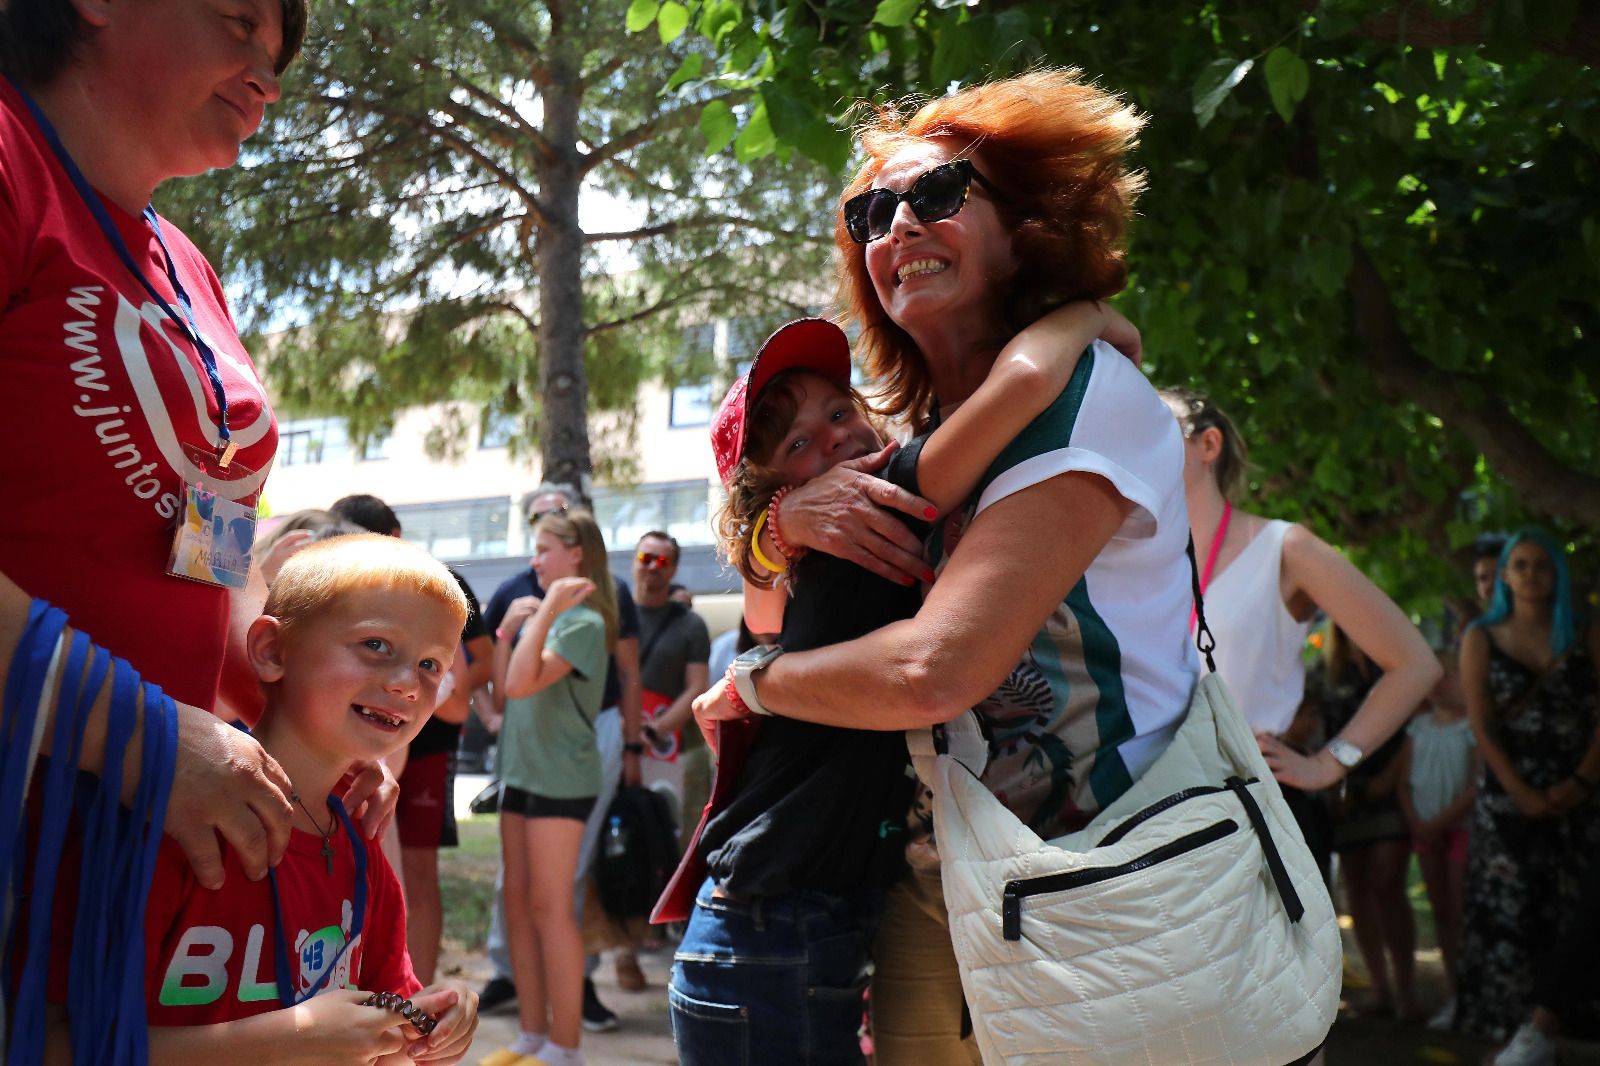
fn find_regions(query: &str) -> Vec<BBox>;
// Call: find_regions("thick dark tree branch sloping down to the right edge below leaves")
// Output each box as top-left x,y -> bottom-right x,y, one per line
1346,243 -> 1600,528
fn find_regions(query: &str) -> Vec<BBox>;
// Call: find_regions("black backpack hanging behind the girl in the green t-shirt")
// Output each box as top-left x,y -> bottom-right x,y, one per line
595,784 -> 678,919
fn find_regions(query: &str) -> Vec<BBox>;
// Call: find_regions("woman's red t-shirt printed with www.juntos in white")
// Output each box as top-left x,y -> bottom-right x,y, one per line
0,78 -> 277,707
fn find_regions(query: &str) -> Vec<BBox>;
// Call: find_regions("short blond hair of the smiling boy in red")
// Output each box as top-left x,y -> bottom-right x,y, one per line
262,533 -> 467,632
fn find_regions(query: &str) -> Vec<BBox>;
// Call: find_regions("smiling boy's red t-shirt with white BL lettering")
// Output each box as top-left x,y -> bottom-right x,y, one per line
144,816 -> 422,1026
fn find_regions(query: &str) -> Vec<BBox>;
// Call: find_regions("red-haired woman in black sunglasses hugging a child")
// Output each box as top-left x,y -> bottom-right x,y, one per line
696,70 -> 1198,1066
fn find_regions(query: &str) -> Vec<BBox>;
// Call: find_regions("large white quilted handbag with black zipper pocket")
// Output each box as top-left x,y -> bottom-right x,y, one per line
907,601 -> 1342,1066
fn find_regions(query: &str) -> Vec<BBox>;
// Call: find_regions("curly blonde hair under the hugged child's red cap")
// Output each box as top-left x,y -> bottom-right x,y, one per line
712,370 -> 883,589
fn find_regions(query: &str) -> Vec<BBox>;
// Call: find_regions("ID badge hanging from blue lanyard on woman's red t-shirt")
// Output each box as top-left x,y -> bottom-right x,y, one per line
166,445 -> 258,589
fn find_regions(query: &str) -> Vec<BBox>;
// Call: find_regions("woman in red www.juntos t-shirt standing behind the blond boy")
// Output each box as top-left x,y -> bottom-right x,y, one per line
0,0 -> 395,1056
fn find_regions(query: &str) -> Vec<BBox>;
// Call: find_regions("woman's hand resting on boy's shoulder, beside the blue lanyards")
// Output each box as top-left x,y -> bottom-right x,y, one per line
166,704 -> 293,888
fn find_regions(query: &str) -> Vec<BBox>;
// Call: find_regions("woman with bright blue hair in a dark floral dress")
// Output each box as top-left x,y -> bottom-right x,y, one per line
1456,528 -> 1600,1043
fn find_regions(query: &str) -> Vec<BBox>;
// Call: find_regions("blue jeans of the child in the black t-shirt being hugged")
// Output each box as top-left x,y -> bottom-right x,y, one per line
667,880 -> 878,1066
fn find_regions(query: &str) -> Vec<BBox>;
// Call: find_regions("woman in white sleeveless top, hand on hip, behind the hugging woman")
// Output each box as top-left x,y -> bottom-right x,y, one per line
1162,389 -> 1440,1010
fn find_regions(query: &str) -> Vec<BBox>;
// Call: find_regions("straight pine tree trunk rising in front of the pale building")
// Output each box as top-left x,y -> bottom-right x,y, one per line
538,17 -> 594,498
